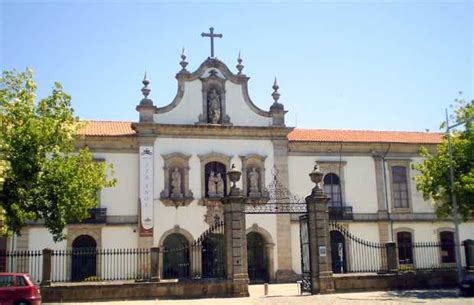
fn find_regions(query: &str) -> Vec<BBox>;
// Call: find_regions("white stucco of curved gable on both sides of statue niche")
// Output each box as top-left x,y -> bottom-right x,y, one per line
154,74 -> 272,126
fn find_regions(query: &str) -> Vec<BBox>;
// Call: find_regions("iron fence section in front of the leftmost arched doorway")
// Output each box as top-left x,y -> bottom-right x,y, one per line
51,248 -> 150,282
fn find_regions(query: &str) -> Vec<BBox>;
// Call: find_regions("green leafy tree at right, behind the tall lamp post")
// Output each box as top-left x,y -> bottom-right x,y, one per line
413,99 -> 474,221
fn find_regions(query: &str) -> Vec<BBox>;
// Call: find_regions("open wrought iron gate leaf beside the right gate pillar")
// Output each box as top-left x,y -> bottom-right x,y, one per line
299,214 -> 312,292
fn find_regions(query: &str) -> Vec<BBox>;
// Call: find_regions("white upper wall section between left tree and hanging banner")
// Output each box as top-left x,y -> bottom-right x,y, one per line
94,153 -> 138,216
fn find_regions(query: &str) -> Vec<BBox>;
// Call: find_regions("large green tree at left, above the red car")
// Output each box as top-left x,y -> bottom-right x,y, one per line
0,70 -> 116,241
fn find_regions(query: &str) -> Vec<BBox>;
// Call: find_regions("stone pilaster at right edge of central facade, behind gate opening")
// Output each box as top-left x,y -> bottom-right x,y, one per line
272,139 -> 297,282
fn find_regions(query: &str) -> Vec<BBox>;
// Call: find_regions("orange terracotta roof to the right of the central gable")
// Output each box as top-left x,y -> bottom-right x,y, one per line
288,129 -> 443,144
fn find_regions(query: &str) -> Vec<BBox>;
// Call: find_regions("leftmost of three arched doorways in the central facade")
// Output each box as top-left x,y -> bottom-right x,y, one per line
163,233 -> 190,279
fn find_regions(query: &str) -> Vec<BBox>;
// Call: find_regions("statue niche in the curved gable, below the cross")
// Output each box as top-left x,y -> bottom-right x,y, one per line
196,69 -> 232,125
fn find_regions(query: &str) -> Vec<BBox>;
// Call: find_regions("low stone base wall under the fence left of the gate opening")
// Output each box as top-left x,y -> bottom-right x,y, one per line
41,280 -> 248,302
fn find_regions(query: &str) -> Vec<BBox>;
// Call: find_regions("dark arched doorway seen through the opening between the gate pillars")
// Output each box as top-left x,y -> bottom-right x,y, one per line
247,232 -> 269,283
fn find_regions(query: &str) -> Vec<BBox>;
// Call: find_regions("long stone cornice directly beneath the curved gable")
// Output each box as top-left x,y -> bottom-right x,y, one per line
132,123 -> 293,140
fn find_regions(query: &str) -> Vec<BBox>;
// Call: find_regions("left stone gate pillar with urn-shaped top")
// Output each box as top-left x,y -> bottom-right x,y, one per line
222,165 -> 249,297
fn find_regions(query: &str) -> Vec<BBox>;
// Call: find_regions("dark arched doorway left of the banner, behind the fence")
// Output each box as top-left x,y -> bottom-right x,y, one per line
71,235 -> 97,281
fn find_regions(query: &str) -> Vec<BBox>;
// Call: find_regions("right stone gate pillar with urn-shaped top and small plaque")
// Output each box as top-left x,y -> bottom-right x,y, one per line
306,164 -> 334,294
